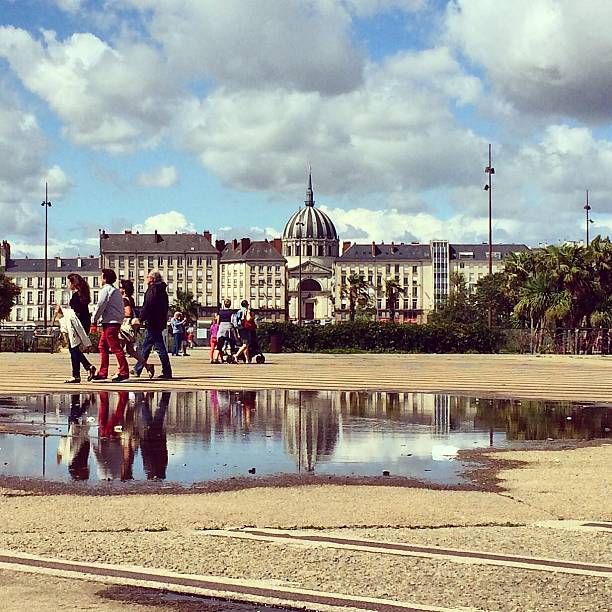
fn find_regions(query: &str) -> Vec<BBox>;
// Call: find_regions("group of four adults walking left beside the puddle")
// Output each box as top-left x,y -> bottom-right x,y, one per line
55,268 -> 172,384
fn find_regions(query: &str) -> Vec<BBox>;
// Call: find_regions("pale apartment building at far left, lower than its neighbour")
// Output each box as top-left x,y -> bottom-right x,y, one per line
3,253 -> 100,327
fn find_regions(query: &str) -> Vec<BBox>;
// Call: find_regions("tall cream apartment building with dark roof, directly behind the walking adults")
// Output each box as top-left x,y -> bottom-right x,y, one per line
100,230 -> 220,314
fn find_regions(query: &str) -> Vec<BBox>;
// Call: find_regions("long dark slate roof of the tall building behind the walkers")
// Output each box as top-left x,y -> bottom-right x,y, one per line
100,233 -> 218,255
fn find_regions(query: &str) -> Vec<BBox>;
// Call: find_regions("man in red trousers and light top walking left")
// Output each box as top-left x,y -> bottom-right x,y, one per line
92,268 -> 130,382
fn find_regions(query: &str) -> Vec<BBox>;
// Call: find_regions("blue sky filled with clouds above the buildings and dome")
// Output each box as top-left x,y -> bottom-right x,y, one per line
0,0 -> 612,257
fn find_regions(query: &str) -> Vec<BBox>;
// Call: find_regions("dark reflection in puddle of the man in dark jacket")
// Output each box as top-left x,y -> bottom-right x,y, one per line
140,391 -> 170,480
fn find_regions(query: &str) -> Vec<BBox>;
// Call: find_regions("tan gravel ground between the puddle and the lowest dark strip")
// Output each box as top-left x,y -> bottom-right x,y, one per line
0,445 -> 612,612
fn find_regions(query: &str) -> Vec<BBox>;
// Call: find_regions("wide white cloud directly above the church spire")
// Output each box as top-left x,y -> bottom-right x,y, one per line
175,48 -> 486,195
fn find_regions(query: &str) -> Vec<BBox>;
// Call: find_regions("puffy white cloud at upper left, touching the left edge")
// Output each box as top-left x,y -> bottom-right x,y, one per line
0,26 -> 183,153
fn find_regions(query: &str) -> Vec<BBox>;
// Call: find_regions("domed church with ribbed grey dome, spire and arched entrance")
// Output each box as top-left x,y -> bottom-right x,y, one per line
282,173 -> 340,322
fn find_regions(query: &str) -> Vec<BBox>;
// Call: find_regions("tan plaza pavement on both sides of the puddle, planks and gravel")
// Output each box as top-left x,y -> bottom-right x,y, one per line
0,352 -> 612,612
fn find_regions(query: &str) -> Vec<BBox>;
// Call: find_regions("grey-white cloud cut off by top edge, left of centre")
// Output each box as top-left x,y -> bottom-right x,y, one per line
119,0 -> 364,94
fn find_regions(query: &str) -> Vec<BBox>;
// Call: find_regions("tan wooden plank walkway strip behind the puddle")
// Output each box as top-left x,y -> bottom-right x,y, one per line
0,350 -> 612,402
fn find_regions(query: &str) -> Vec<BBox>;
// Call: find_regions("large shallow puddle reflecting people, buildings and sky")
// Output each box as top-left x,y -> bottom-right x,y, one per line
0,390 -> 612,484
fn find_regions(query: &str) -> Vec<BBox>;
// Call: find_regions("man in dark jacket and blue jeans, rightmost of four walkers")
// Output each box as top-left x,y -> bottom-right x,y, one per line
134,270 -> 172,380
